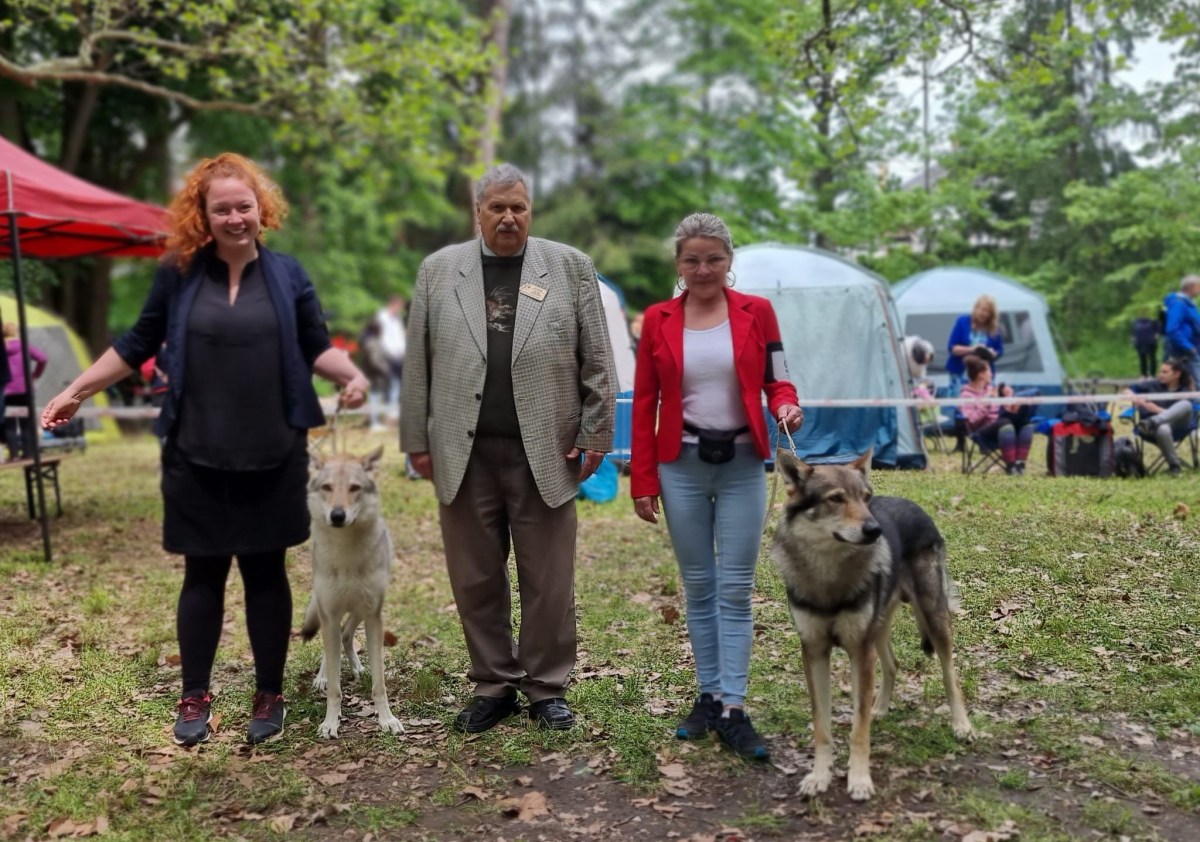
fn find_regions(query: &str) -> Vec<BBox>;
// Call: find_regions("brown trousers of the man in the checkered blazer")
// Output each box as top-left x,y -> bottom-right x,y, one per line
434,437 -> 576,702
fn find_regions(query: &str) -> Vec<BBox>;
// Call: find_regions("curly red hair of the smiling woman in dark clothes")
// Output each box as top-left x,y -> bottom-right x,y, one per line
164,152 -> 288,269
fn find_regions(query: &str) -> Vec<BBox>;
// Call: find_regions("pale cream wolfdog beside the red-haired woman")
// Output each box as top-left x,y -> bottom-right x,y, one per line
300,446 -> 404,739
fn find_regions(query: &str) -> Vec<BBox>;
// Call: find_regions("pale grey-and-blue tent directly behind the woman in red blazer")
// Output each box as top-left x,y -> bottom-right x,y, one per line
733,243 -> 926,468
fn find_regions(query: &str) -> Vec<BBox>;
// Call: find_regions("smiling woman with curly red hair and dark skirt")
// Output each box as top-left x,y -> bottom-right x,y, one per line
42,152 -> 368,745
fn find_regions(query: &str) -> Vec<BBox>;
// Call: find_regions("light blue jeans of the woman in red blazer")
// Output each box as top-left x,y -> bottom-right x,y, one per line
659,443 -> 767,705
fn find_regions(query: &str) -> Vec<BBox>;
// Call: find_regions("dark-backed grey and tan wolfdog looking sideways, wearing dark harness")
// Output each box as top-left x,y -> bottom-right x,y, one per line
773,450 -> 974,801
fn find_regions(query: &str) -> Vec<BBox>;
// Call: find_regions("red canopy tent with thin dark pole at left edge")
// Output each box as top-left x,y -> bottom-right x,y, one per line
0,137 -> 167,561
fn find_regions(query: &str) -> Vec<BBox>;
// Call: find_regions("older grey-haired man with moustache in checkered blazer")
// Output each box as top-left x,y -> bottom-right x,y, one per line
401,164 -> 617,733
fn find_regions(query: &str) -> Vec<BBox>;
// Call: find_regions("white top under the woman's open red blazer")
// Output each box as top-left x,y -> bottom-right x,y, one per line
683,319 -> 752,443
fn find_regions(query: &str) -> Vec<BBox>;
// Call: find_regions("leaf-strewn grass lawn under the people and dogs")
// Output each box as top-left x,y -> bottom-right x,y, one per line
0,431 -> 1200,842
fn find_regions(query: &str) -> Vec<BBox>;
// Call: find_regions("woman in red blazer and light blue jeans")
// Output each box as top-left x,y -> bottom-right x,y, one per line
630,213 -> 804,759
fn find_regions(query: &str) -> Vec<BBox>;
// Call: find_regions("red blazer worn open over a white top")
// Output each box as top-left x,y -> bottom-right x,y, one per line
630,289 -> 799,499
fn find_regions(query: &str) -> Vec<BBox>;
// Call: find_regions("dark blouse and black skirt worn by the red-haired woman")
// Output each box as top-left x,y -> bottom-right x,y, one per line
162,255 -> 308,555
